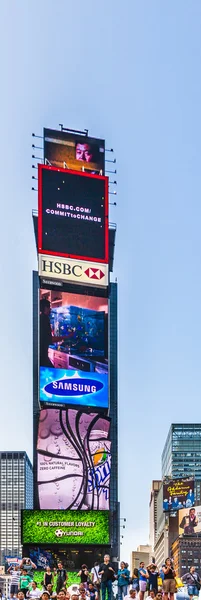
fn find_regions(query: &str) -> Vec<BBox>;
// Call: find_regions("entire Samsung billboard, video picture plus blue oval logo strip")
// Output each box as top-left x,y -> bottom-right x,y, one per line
40,289 -> 108,409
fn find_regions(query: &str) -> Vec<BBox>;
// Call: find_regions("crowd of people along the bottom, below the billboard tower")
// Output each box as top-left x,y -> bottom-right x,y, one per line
4,554 -> 201,600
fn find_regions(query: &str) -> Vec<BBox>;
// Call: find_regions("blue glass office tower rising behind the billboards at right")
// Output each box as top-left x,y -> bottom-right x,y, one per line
162,423 -> 201,503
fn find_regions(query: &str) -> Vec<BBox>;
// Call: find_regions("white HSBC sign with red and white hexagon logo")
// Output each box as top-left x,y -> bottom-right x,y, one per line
38,254 -> 108,287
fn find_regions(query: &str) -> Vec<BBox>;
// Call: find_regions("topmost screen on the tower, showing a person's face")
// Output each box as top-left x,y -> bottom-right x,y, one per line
44,129 -> 105,175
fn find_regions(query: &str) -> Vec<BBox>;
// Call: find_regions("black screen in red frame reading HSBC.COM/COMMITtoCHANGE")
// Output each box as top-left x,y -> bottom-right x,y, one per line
38,165 -> 109,263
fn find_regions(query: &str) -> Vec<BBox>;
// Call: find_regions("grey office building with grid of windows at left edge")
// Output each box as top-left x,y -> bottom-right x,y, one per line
0,452 -> 33,565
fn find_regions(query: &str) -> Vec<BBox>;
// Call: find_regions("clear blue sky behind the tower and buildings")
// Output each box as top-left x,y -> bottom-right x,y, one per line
0,0 -> 201,560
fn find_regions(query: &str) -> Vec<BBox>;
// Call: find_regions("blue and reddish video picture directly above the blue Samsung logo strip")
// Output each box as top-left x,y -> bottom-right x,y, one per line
39,289 -> 108,373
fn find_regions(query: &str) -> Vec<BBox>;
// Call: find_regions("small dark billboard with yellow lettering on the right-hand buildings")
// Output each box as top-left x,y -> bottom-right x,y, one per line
163,478 -> 195,512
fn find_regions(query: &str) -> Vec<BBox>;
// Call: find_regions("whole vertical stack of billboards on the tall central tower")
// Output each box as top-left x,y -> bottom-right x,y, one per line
22,129 -> 111,568
